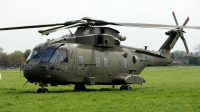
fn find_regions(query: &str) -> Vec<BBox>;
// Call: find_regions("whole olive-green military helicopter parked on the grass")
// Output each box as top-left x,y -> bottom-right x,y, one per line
0,12 -> 200,93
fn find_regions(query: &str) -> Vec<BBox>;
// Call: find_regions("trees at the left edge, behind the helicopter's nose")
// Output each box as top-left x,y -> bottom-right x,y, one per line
0,48 -> 31,69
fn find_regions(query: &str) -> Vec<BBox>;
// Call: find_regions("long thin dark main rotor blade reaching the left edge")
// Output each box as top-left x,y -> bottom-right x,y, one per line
0,23 -> 64,30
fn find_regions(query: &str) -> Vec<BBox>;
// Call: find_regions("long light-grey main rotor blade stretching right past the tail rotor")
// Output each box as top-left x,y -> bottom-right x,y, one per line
111,23 -> 200,29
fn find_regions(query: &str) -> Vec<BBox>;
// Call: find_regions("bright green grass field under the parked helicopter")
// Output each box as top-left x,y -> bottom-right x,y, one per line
0,66 -> 200,112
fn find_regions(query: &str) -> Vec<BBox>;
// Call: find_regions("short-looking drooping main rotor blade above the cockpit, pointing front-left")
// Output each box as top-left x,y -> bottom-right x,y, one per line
38,23 -> 85,35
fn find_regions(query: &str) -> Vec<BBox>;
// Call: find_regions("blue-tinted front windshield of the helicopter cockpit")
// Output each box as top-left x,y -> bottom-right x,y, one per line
26,49 -> 55,61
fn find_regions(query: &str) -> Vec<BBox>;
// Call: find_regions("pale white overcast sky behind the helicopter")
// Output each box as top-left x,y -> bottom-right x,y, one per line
0,0 -> 200,53
